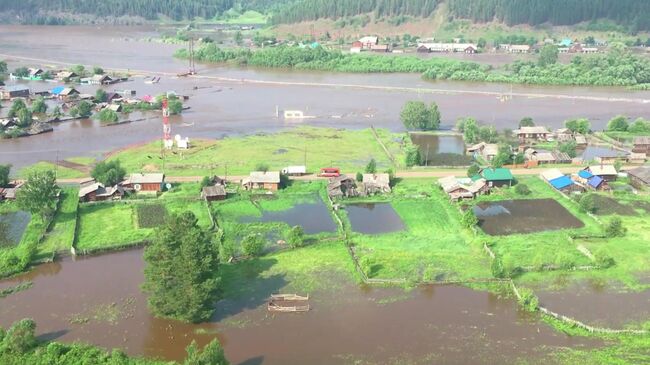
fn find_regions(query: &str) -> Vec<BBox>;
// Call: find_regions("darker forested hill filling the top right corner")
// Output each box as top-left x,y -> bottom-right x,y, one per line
447,0 -> 650,30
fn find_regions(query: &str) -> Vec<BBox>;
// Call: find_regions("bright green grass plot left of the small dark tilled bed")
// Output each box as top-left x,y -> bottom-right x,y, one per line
76,203 -> 153,251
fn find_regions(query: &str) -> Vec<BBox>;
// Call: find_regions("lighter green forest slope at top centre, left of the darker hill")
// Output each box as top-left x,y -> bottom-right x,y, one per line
271,0 -> 439,23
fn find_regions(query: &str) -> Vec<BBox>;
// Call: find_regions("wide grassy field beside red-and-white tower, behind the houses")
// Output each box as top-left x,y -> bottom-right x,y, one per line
110,127 -> 404,176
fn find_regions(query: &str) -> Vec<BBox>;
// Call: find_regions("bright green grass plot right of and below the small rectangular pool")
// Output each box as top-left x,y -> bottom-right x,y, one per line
343,180 -> 492,281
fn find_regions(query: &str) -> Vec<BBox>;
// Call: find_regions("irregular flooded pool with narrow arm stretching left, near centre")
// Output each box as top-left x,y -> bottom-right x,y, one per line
240,197 -> 336,234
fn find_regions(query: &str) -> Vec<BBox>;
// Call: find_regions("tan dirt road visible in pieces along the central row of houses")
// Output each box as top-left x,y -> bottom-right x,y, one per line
57,166 -> 580,184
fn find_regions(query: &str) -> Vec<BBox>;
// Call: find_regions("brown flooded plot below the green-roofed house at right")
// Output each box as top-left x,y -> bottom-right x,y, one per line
473,199 -> 584,236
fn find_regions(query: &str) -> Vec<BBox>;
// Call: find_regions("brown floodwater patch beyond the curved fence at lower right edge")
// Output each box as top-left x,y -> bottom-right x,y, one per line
535,280 -> 650,328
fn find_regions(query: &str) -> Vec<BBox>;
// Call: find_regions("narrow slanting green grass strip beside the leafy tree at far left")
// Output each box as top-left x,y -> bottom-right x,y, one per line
38,188 -> 79,254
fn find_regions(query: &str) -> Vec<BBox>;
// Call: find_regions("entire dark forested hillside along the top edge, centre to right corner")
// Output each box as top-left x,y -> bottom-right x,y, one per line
272,0 -> 650,30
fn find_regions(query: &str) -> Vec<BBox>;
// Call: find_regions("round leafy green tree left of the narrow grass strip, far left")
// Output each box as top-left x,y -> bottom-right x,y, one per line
16,171 -> 59,221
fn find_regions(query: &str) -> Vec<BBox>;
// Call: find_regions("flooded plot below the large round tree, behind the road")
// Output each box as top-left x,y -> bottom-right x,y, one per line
410,133 -> 472,166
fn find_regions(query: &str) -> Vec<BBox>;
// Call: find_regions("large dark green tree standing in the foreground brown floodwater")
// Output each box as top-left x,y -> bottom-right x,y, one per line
142,212 -> 219,323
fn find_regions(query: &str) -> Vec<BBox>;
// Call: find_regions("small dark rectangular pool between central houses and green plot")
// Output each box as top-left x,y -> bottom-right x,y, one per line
345,203 -> 404,234
